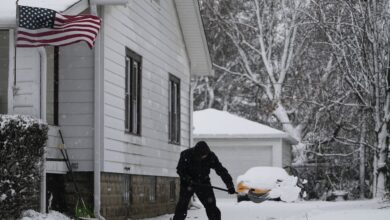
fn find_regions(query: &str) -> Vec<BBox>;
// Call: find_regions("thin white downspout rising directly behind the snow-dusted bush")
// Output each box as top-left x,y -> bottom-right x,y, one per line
38,47 -> 47,213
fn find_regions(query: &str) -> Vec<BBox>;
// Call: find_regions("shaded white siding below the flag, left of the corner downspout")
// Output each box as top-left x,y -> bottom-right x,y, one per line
57,43 -> 94,171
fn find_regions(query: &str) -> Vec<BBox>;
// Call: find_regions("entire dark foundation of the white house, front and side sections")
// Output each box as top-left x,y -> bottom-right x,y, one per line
48,172 -> 179,220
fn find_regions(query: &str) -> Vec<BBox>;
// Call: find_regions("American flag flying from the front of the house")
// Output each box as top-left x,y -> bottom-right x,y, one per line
16,6 -> 101,48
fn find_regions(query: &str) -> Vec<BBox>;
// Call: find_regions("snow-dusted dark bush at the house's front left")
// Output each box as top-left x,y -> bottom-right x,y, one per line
0,115 -> 48,219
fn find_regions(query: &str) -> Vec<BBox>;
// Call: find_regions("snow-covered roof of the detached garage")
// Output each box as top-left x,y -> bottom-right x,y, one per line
193,109 -> 295,142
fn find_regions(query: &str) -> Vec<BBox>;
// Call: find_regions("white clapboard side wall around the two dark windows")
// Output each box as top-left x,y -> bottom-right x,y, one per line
103,0 -> 190,176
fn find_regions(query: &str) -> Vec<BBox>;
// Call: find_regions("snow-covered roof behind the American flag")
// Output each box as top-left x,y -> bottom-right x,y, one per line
0,0 -> 83,28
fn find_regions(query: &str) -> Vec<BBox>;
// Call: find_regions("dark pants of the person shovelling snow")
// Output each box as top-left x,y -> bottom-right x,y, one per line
173,185 -> 221,220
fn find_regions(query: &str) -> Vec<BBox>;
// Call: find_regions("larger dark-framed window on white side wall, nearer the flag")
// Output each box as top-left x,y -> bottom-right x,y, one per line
125,48 -> 142,135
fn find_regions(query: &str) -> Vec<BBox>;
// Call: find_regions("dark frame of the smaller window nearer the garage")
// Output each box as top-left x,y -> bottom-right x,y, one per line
168,74 -> 181,145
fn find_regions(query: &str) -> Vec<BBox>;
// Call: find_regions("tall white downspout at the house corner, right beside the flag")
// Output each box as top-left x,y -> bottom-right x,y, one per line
90,0 -> 127,220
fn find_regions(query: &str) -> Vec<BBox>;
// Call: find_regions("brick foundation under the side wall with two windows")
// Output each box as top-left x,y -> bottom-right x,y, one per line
101,173 -> 179,220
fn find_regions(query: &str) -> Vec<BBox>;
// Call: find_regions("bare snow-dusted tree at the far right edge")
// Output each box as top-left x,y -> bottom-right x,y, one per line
318,0 -> 390,197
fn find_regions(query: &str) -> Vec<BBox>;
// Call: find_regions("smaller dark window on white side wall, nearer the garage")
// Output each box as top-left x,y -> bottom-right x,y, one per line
168,75 -> 180,144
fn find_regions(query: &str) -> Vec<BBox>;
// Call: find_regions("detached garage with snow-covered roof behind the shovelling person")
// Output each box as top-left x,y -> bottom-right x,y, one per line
193,109 -> 298,197
